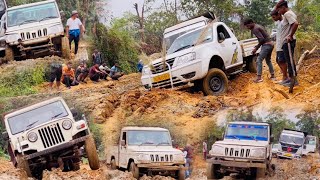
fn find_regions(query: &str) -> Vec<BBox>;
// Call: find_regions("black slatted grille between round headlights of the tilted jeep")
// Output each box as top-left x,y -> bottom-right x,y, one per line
38,123 -> 64,148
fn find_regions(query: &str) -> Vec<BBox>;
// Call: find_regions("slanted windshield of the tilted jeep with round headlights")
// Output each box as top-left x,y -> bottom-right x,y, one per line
8,101 -> 68,135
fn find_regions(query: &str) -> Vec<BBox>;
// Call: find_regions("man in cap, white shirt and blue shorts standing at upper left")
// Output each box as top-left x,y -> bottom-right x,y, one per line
66,11 -> 86,54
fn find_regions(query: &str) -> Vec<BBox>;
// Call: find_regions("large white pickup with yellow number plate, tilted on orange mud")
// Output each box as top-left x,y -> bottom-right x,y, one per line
141,17 -> 259,95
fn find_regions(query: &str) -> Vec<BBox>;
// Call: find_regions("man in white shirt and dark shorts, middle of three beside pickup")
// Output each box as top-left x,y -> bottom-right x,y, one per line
271,10 -> 290,84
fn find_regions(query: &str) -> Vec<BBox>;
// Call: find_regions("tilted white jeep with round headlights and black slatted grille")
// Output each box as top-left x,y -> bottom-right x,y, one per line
3,97 -> 99,178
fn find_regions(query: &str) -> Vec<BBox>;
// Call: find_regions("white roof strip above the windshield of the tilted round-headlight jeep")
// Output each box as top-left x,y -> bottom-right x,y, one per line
3,97 -> 65,121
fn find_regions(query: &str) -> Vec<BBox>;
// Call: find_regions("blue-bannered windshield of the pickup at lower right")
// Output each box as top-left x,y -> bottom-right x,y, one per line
225,124 -> 268,141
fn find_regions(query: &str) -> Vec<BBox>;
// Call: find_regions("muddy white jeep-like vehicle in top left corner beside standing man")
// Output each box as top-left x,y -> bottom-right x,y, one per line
0,0 -> 70,61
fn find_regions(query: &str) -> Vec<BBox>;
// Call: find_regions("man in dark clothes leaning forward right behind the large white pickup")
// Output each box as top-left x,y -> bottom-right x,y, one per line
244,19 -> 275,83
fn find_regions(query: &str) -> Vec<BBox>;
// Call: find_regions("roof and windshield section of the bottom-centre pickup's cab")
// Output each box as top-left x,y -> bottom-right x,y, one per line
120,127 -> 172,146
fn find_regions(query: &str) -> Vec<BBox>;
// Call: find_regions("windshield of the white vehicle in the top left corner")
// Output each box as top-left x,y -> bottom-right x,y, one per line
7,2 -> 59,27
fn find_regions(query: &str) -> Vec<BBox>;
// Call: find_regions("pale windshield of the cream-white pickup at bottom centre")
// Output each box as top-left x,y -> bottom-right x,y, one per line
128,131 -> 171,146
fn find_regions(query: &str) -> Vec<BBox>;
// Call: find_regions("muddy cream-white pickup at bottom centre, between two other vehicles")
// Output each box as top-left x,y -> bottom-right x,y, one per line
106,127 -> 185,180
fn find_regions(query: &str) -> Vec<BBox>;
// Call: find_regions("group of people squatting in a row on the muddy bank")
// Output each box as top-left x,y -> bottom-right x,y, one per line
49,51 -> 124,90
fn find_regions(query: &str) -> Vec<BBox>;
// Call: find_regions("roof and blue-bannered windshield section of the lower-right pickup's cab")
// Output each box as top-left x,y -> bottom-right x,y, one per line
224,122 -> 272,142
